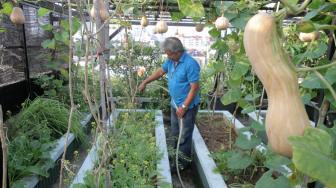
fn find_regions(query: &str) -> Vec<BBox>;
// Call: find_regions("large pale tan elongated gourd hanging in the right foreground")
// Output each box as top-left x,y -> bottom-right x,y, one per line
244,13 -> 309,157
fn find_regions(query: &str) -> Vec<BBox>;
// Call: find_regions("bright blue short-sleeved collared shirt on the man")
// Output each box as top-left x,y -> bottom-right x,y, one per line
162,52 -> 200,108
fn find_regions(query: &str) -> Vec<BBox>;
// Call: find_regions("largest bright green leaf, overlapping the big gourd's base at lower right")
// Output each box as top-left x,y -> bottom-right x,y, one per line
288,127 -> 336,187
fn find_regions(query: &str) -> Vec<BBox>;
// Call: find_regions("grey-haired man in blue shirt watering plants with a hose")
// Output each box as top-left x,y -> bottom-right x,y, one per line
139,37 -> 200,169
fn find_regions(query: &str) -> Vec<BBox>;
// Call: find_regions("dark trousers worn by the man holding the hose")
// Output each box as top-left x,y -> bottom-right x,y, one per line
171,105 -> 198,166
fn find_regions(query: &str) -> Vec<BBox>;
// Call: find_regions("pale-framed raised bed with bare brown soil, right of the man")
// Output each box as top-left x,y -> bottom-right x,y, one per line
193,110 -> 270,187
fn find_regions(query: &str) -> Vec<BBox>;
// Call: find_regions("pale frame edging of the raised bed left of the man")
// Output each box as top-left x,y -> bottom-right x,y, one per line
70,109 -> 172,187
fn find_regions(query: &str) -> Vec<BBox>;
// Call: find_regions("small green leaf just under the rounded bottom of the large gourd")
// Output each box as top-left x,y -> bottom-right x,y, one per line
265,154 -> 292,175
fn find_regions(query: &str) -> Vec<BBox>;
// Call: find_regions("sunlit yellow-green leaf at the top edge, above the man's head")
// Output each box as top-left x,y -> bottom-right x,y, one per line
177,0 -> 204,18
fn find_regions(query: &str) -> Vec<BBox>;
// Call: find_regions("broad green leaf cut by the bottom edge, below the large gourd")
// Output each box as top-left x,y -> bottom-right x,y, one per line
255,170 -> 291,188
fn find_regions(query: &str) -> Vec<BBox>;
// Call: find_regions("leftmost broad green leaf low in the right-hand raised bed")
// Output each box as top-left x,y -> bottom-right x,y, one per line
228,152 -> 253,170
